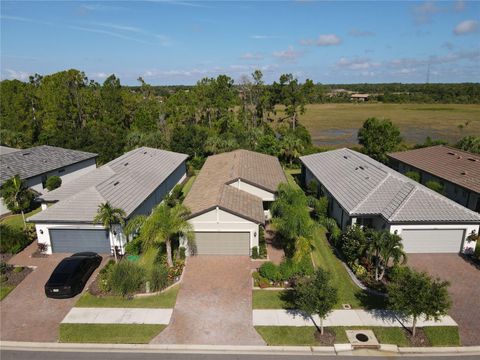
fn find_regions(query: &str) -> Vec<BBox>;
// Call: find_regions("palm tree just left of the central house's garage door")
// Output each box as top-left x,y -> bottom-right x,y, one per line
141,203 -> 193,267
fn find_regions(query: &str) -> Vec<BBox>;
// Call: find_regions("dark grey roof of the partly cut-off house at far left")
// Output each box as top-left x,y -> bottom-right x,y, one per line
0,145 -> 97,184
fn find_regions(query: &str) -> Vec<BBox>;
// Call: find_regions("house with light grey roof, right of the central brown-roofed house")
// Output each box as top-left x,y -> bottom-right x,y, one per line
300,149 -> 480,253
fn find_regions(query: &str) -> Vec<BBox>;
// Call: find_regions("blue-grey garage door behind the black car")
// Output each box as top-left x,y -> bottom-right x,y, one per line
50,229 -> 110,254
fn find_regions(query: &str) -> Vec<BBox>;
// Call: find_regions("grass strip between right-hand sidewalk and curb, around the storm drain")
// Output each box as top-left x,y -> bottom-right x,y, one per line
255,326 -> 416,346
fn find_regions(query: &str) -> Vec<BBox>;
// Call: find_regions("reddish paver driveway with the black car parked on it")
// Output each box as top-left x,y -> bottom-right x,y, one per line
0,243 -> 107,342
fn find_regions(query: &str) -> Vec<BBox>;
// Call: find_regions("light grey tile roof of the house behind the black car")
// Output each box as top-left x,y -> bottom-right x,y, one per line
29,147 -> 188,223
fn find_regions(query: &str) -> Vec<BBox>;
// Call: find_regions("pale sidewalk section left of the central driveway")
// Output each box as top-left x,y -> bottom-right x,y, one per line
62,308 -> 173,325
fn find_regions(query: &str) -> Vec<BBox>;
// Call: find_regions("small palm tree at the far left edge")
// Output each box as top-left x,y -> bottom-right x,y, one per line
0,175 -> 33,229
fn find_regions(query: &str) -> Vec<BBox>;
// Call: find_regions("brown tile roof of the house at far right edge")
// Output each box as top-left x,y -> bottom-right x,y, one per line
388,145 -> 480,193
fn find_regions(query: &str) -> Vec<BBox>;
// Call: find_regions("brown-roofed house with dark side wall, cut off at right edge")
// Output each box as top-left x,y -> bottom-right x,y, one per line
388,145 -> 480,212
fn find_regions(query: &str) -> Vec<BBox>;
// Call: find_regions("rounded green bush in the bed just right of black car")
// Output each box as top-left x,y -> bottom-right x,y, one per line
108,260 -> 145,296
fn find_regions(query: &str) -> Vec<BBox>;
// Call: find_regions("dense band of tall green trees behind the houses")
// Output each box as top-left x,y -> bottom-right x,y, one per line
0,69 -> 315,167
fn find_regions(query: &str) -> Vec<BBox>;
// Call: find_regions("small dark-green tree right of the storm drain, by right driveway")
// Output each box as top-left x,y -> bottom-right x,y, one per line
387,267 -> 451,336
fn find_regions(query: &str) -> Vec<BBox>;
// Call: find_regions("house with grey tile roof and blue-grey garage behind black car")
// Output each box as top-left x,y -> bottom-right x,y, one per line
28,147 -> 188,253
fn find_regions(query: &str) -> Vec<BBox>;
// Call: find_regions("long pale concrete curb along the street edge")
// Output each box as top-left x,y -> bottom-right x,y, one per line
0,341 -> 480,356
